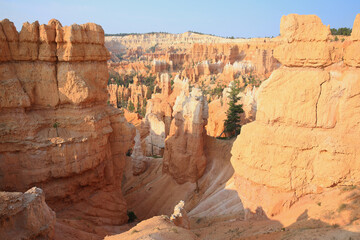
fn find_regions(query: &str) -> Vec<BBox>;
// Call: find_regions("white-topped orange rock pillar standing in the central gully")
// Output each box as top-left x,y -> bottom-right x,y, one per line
163,88 -> 208,183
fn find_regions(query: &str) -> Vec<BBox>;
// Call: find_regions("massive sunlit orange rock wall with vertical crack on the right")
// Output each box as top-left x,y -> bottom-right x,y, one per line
231,14 -> 360,216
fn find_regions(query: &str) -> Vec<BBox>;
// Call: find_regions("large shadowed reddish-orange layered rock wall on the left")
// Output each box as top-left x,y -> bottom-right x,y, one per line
0,19 -> 135,229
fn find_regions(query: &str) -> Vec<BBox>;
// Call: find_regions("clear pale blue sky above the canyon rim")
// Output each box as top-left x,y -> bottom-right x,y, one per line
0,0 -> 360,38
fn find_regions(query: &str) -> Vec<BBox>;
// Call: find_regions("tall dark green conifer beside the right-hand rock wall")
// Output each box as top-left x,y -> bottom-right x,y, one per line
224,83 -> 244,136
